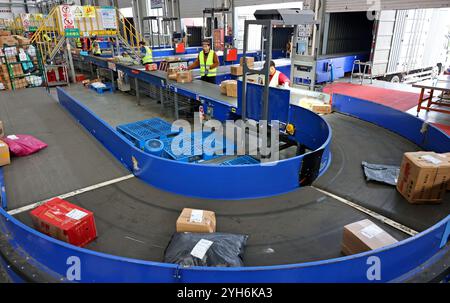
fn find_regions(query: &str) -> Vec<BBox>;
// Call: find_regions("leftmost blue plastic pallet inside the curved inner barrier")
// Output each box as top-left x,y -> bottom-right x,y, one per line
116,118 -> 178,149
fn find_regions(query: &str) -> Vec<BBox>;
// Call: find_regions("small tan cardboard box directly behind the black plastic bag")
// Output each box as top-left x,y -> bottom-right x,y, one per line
176,208 -> 216,233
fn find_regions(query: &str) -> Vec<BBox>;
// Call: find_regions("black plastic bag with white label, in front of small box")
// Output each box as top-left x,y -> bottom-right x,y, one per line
164,233 -> 248,267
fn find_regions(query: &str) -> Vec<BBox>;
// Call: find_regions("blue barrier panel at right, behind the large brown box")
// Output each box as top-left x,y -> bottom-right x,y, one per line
333,94 -> 450,153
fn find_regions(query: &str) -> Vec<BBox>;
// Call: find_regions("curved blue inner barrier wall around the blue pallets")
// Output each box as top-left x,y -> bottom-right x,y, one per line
58,88 -> 329,199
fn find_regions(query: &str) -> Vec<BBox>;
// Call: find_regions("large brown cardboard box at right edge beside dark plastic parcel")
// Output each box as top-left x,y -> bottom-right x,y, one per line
397,152 -> 450,204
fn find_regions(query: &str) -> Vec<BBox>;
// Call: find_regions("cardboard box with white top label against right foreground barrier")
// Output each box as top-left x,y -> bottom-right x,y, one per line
341,219 -> 397,255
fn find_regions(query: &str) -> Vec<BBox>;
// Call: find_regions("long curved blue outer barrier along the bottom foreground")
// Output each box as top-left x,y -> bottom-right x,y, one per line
0,197 -> 450,283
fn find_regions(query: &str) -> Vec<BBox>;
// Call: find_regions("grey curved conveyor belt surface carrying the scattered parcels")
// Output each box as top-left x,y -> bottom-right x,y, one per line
0,89 -> 450,266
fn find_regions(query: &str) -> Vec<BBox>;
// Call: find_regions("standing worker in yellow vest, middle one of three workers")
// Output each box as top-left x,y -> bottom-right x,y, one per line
188,40 -> 220,84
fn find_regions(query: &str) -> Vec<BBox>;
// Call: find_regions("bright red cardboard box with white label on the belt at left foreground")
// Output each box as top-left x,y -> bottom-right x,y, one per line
30,198 -> 97,247
